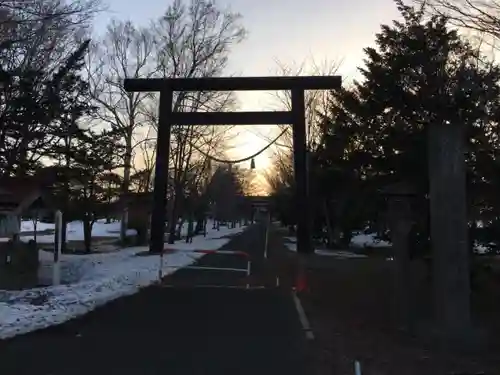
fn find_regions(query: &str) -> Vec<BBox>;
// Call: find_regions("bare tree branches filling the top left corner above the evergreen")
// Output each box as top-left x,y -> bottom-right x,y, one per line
0,0 -> 103,74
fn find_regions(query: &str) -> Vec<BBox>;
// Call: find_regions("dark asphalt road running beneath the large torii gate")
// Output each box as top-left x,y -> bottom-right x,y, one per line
0,225 -> 309,375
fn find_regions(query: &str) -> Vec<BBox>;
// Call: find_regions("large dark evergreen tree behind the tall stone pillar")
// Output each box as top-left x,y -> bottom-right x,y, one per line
320,2 -> 500,245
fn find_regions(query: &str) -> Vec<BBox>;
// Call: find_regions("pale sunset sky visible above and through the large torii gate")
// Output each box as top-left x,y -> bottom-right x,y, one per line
95,0 -> 398,183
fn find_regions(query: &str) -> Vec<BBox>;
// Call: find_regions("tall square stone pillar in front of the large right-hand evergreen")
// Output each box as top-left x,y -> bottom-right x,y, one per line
428,123 -> 471,339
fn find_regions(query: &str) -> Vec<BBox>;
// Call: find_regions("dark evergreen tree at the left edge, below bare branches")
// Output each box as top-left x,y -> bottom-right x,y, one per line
0,42 -> 92,175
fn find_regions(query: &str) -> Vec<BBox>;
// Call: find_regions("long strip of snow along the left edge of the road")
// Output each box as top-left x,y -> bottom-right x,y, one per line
0,222 -> 245,339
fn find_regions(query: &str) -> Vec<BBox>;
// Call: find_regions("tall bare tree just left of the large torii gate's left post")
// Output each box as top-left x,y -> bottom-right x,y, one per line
87,20 -> 155,239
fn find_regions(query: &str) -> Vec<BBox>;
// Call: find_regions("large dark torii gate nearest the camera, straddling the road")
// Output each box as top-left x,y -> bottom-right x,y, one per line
124,76 -> 341,253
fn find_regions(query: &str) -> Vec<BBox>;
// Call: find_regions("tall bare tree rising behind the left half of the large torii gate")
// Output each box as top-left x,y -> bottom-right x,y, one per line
145,0 -> 245,241
